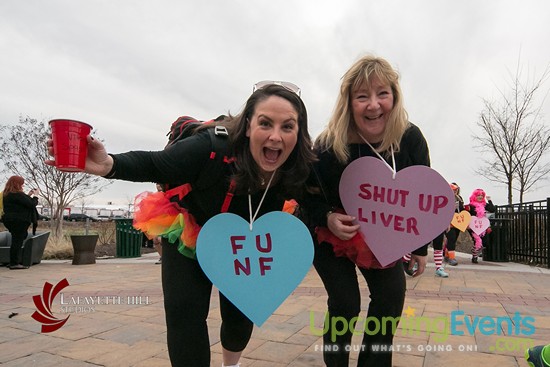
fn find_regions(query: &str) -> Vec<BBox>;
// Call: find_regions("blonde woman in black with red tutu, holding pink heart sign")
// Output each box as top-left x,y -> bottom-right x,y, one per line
304,56 -> 430,367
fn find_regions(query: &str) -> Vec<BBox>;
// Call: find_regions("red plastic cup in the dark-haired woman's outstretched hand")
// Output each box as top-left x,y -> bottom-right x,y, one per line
50,119 -> 92,172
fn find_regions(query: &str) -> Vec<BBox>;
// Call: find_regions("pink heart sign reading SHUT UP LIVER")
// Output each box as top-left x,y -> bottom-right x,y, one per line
339,157 -> 455,266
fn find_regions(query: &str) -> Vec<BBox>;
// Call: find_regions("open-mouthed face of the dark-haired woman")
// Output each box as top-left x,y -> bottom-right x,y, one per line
246,96 -> 299,175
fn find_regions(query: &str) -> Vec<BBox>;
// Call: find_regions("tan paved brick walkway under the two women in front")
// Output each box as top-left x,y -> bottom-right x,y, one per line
0,254 -> 550,367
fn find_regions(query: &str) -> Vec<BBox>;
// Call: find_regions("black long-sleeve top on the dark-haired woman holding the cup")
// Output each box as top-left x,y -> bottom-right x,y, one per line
105,131 -> 284,226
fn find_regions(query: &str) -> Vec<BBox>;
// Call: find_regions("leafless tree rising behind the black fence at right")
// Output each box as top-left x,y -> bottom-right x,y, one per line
473,61 -> 550,204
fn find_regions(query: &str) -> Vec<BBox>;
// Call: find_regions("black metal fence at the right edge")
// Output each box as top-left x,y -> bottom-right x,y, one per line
491,198 -> 550,268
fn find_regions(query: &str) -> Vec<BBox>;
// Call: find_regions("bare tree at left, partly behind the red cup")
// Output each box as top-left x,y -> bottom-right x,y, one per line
0,117 -> 110,236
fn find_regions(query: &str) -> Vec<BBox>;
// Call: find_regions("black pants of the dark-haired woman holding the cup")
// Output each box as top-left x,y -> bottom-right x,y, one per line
162,239 -> 253,367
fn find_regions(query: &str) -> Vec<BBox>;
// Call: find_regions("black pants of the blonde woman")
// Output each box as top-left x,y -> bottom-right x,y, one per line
313,243 -> 406,367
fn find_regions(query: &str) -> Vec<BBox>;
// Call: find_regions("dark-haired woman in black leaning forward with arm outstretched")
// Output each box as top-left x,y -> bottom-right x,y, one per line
47,82 -> 314,367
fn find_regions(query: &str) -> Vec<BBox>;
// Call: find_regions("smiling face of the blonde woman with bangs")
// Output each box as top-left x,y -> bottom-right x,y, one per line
351,78 -> 393,143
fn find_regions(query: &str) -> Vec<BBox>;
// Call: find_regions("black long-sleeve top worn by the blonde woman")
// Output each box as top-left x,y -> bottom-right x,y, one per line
304,123 -> 430,256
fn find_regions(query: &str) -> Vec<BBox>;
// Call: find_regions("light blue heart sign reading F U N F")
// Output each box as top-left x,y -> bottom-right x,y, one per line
197,212 -> 313,326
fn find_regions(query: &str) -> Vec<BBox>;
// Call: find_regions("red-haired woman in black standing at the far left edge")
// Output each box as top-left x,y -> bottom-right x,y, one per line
2,176 -> 38,270
